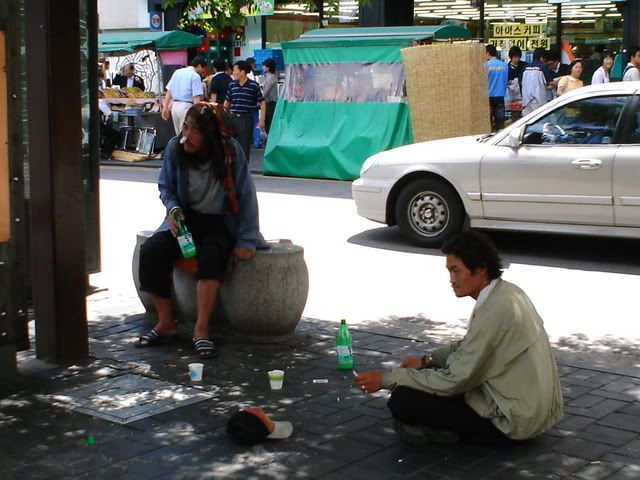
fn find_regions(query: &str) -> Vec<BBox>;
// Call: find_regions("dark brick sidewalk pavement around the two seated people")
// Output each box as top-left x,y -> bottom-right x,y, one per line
0,284 -> 640,480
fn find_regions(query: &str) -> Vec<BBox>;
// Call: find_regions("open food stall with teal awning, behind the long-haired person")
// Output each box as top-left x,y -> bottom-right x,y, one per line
98,30 -> 202,161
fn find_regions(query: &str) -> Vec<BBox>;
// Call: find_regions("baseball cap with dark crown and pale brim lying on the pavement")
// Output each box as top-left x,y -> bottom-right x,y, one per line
227,407 -> 293,446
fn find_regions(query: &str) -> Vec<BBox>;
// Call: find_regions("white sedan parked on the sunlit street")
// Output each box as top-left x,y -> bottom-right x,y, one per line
352,82 -> 640,247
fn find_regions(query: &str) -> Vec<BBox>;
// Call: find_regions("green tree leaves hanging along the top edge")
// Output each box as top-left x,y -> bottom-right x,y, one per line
162,0 -> 371,33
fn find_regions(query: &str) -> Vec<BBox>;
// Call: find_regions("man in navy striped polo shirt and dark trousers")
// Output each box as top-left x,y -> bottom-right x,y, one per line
224,60 -> 266,159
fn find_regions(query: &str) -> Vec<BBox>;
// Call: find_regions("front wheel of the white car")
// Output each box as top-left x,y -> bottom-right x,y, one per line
395,178 -> 464,247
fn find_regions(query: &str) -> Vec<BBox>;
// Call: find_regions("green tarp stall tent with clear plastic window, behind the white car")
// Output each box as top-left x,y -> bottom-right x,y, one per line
263,25 -> 471,180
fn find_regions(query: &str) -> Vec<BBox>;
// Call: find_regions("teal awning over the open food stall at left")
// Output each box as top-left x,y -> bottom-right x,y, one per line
98,30 -> 202,53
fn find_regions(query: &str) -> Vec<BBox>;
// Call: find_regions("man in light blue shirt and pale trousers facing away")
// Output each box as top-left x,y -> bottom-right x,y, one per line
161,56 -> 207,139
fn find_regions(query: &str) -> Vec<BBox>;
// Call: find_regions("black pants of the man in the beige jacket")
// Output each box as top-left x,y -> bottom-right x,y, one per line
387,387 -> 511,444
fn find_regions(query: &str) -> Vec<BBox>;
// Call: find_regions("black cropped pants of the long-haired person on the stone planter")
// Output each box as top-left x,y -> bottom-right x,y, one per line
140,211 -> 233,298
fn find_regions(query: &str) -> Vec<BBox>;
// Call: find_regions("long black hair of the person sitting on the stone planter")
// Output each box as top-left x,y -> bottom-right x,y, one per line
176,102 -> 225,179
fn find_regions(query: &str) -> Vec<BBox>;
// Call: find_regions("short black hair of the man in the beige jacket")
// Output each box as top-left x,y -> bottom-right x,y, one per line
441,231 -> 502,280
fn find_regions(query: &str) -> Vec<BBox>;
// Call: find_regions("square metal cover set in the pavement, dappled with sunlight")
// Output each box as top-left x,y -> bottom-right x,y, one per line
41,374 -> 213,424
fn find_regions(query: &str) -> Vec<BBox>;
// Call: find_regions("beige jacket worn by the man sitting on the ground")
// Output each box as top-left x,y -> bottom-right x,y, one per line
382,280 -> 563,439
